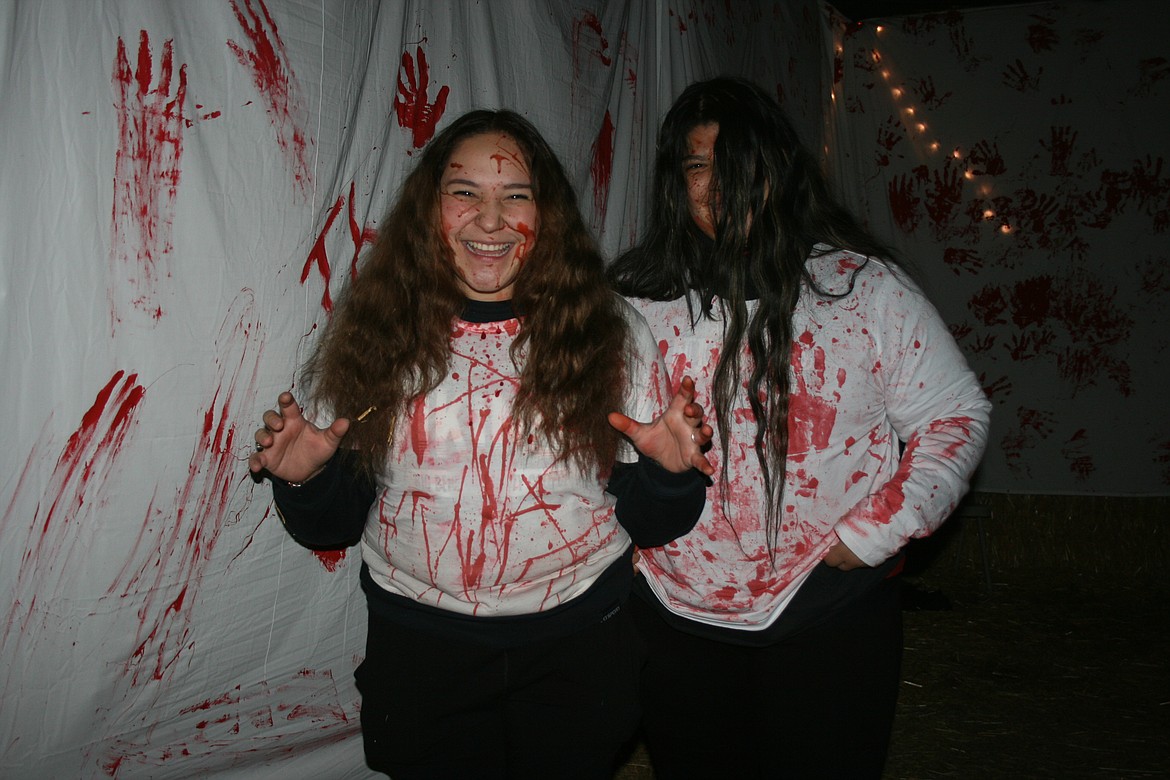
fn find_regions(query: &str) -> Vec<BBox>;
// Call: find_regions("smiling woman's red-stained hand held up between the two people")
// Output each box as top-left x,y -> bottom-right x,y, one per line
610,377 -> 715,476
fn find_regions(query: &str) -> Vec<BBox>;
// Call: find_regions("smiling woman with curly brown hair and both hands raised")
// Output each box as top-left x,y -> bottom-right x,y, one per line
249,111 -> 713,780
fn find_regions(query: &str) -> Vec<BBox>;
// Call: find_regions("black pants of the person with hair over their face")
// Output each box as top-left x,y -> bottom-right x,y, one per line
631,580 -> 902,780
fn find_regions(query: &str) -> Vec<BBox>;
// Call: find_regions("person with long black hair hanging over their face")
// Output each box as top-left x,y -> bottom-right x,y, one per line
610,78 -> 990,779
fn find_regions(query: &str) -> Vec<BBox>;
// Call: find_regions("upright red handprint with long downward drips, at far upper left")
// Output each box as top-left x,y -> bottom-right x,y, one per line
111,30 -> 188,322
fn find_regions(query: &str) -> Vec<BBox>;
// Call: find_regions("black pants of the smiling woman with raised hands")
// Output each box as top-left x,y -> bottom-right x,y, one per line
355,607 -> 645,780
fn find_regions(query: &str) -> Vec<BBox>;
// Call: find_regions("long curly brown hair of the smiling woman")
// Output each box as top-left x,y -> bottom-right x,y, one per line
305,111 -> 628,475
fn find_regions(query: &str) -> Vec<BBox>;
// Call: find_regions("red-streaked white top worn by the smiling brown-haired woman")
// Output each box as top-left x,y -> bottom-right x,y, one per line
362,295 -> 669,616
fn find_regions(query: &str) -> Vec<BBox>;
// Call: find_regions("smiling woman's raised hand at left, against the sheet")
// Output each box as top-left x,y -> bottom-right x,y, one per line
248,393 -> 350,482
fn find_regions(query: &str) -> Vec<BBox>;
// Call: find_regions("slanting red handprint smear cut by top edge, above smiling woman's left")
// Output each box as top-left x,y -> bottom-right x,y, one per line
227,0 -> 312,192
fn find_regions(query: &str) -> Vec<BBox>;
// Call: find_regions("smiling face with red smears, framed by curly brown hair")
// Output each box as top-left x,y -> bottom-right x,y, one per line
439,132 -> 539,301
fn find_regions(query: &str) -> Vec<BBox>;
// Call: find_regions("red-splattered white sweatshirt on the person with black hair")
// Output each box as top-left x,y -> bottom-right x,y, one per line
633,251 -> 991,629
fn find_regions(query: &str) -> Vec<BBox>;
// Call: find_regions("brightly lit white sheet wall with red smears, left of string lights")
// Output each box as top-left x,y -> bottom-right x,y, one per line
0,0 -> 827,779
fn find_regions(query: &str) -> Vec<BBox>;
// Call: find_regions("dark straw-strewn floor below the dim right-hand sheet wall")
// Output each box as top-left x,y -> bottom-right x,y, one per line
615,523 -> 1170,780
